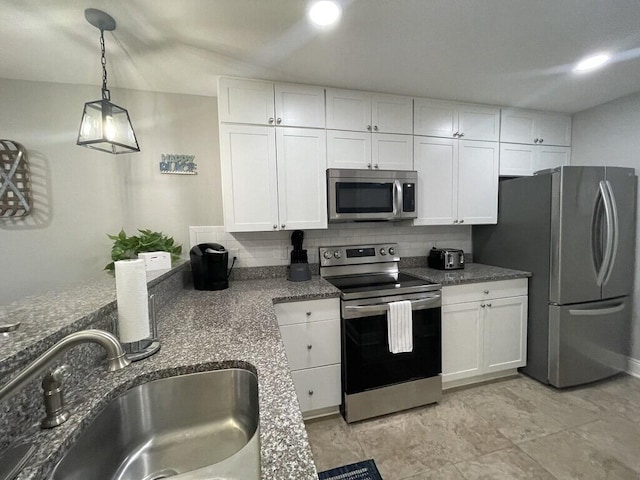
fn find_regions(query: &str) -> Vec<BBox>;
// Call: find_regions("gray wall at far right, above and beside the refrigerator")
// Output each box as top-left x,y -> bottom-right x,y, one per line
571,93 -> 640,360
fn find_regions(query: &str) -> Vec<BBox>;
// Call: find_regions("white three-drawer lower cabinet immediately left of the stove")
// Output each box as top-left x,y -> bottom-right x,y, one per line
274,298 -> 342,417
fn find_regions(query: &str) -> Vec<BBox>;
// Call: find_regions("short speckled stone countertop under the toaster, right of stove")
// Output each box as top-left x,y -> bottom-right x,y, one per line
402,263 -> 531,286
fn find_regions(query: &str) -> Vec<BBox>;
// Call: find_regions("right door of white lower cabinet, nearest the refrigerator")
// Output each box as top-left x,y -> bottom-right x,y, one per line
483,296 -> 528,373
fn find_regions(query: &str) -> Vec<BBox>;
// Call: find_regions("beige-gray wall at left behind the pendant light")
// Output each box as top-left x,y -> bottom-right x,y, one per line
0,79 -> 222,304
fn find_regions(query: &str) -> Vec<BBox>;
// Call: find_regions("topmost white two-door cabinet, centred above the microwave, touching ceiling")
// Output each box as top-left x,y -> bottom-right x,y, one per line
327,88 -> 413,135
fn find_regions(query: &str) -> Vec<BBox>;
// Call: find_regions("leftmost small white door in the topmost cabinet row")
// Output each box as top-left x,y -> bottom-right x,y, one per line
218,77 -> 275,125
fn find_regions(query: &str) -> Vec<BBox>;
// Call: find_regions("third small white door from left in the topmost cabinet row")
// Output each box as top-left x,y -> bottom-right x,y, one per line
327,88 -> 371,132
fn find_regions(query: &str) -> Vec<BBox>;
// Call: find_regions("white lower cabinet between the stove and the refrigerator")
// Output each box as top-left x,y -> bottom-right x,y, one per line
442,279 -> 528,387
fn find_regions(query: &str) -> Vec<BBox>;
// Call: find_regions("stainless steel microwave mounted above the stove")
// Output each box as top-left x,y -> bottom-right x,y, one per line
327,168 -> 418,223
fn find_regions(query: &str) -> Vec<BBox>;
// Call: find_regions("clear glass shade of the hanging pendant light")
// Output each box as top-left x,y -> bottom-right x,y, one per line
77,99 -> 140,154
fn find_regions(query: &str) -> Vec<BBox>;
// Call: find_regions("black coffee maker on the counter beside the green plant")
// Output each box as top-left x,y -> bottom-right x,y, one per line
189,243 -> 229,290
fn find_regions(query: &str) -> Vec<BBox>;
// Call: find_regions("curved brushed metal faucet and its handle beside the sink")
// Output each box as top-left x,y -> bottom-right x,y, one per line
0,329 -> 131,428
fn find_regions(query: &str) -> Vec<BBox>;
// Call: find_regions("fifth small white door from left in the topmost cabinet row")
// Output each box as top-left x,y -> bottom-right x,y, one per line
413,98 -> 458,138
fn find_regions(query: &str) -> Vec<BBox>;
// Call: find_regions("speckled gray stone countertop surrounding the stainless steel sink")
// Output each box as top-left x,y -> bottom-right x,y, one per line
10,276 -> 339,480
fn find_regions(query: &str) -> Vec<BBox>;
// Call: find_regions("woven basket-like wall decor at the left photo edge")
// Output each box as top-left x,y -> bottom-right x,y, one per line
0,140 -> 33,218
